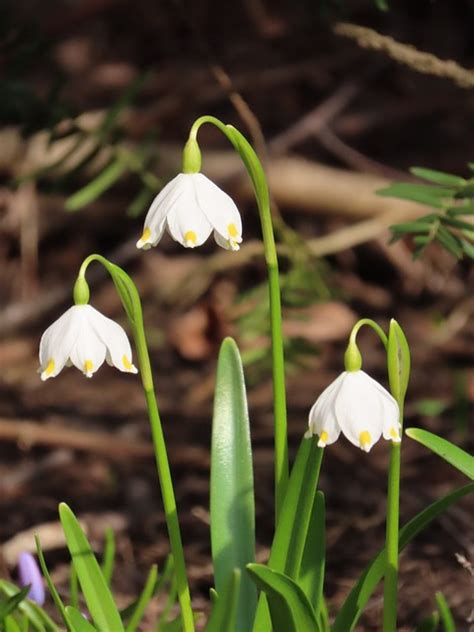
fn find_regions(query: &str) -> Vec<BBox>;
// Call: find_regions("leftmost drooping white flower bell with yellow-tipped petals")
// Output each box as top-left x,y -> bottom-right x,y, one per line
39,305 -> 138,380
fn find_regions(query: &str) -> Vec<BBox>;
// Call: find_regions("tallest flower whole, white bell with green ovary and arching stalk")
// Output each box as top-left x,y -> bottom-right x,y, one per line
137,116 -> 288,520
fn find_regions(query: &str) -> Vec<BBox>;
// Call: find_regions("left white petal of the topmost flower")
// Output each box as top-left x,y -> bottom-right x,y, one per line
137,173 -> 189,250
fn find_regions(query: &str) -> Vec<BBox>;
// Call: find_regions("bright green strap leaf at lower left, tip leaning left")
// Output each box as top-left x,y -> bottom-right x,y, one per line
59,503 -> 124,632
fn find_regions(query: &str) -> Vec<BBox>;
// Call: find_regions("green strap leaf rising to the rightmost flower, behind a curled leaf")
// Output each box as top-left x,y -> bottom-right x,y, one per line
253,437 -> 324,632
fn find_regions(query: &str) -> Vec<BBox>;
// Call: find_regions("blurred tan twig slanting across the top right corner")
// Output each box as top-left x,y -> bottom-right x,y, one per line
334,22 -> 474,89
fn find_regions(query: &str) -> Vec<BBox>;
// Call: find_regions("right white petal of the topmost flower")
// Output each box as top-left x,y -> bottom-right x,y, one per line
193,173 -> 242,250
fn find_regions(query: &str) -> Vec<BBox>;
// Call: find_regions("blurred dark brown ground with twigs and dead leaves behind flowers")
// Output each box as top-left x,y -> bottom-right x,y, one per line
0,0 -> 474,631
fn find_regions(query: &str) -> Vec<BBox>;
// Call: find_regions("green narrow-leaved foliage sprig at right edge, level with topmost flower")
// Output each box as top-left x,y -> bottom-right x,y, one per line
377,163 -> 474,259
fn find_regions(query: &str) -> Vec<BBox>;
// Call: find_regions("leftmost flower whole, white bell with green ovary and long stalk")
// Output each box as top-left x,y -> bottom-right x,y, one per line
40,254 -> 194,632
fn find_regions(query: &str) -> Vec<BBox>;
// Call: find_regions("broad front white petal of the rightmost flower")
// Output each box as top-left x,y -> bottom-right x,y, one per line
335,371 -> 383,452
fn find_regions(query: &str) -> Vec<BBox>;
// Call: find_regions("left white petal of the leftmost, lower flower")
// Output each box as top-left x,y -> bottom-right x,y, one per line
39,305 -> 85,380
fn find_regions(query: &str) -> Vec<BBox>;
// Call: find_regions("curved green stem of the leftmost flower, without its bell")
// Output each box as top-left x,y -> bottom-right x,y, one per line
78,254 -> 194,632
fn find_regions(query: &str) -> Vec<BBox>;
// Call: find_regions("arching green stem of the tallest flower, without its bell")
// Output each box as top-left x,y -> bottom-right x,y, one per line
189,116 -> 288,522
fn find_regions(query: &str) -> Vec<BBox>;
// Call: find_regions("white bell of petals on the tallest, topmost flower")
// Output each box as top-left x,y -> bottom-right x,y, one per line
137,173 -> 242,250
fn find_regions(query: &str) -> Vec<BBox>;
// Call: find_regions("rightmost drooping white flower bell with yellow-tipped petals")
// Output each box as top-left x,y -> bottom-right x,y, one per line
307,370 -> 400,452
